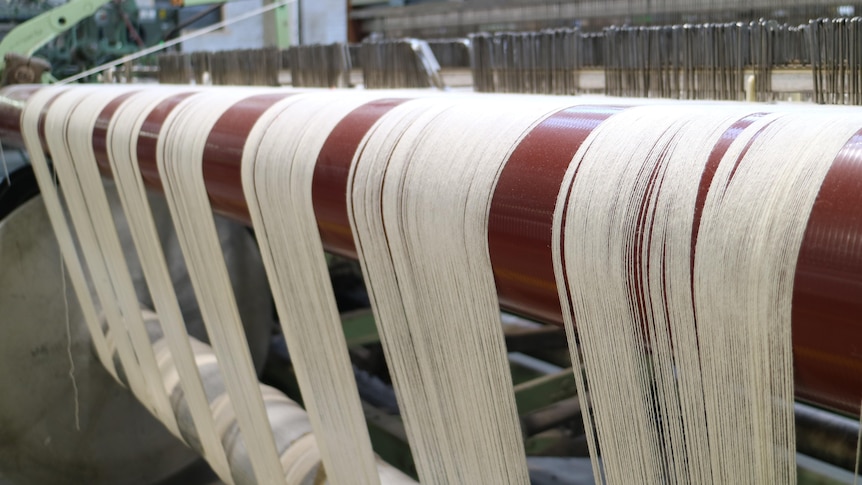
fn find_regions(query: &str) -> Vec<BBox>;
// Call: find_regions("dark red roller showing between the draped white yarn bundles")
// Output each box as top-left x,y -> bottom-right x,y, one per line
0,86 -> 862,415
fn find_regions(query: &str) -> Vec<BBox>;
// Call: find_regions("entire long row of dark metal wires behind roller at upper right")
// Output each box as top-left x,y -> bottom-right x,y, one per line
471,17 -> 862,105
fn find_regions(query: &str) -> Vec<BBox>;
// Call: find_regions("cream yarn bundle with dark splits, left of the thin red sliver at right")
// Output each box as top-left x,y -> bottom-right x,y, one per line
554,107 -> 756,483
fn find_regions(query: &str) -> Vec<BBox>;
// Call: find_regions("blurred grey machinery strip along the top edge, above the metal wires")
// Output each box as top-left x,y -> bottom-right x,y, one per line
350,0 -> 859,38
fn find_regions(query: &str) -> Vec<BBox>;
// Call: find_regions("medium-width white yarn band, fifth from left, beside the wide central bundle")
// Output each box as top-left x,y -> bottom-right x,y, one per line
243,94 -> 380,484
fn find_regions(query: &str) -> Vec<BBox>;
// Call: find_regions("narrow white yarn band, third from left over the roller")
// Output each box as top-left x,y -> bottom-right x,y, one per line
106,88 -> 233,483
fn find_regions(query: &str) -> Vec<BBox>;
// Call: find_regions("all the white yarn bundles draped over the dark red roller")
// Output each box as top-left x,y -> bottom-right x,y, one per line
21,82 -> 862,484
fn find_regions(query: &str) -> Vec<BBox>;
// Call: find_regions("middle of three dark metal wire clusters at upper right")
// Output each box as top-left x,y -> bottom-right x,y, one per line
604,21 -> 808,101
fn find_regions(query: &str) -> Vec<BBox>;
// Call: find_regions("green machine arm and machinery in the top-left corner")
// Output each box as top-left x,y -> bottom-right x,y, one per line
0,0 -> 236,85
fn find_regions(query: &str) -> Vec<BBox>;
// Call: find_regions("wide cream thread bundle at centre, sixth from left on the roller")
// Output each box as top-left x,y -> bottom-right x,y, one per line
348,94 -> 571,483
